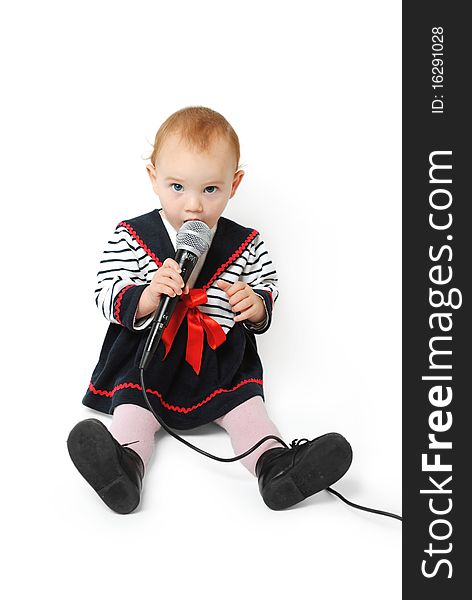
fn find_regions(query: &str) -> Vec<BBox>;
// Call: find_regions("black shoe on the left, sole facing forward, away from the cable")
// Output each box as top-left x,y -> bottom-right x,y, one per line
67,419 -> 144,515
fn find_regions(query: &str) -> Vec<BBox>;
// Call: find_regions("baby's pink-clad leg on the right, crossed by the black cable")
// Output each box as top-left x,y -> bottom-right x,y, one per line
214,396 -> 284,475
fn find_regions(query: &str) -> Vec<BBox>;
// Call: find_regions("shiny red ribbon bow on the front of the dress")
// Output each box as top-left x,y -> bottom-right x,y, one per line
161,288 -> 226,375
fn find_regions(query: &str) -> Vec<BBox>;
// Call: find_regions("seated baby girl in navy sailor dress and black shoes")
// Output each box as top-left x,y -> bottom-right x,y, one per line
67,106 -> 352,514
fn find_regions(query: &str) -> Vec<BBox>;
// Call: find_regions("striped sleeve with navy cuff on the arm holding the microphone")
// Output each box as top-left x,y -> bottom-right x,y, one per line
95,225 -> 152,331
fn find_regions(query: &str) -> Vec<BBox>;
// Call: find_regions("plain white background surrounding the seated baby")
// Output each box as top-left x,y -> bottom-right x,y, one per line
0,0 -> 401,600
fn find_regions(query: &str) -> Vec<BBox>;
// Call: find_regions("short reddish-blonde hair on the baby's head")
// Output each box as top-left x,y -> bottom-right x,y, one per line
147,106 -> 240,169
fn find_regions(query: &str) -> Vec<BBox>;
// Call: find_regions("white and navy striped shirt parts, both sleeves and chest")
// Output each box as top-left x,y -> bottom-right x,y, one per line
95,211 -> 279,334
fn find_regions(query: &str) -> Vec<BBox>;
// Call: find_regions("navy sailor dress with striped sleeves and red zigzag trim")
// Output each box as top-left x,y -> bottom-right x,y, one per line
82,209 -> 278,430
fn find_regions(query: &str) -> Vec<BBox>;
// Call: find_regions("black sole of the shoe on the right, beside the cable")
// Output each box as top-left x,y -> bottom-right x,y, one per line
263,433 -> 352,510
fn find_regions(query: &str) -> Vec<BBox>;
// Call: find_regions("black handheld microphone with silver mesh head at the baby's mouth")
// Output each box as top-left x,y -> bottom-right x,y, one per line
139,221 -> 211,370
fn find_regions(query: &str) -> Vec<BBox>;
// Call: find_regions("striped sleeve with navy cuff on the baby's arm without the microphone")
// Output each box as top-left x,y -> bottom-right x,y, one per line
240,233 -> 279,334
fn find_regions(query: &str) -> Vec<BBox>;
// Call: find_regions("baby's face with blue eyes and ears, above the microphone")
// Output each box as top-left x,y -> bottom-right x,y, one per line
146,134 -> 244,230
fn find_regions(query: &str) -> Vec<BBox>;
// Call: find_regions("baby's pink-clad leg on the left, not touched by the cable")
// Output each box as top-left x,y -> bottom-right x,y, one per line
110,404 -> 161,466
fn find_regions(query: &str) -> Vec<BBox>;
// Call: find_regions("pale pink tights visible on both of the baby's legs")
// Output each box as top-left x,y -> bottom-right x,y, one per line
110,396 -> 282,475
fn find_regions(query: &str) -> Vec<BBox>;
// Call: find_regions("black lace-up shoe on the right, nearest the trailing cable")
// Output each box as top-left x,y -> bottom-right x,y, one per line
255,433 -> 352,510
